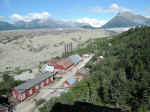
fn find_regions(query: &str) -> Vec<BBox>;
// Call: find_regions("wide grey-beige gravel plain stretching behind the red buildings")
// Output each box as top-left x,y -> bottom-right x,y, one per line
0,29 -> 114,72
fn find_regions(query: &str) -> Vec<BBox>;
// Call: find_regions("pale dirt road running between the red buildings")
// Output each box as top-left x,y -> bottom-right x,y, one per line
16,55 -> 93,112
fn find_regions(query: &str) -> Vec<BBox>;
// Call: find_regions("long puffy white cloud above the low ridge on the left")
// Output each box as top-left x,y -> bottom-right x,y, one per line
10,12 -> 51,22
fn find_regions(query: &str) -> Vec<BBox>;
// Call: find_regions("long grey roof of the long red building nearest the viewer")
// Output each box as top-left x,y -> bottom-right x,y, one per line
15,73 -> 52,93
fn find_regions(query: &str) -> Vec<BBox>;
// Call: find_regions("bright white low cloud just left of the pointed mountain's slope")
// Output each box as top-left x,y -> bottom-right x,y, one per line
76,18 -> 107,27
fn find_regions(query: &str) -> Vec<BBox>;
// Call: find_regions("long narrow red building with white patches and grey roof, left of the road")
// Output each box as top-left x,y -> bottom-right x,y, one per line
12,73 -> 53,102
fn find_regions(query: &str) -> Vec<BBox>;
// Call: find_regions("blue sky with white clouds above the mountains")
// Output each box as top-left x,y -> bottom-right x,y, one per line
0,0 -> 150,27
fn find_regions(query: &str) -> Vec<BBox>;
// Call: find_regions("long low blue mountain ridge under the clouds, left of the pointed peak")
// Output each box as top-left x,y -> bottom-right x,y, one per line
0,19 -> 91,30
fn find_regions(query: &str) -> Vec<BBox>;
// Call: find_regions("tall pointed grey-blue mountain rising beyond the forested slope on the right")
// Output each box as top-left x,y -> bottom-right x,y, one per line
102,12 -> 150,28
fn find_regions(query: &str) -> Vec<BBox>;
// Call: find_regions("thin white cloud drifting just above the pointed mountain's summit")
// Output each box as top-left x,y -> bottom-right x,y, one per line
92,3 -> 132,13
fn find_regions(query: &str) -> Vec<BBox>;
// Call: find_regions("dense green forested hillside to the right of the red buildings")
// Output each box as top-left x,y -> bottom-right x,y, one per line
40,27 -> 150,112
